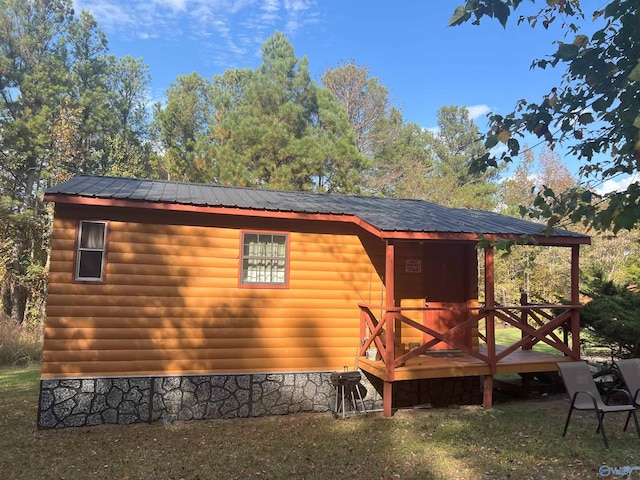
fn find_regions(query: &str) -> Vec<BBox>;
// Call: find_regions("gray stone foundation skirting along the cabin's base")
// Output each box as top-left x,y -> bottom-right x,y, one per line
38,372 -> 482,428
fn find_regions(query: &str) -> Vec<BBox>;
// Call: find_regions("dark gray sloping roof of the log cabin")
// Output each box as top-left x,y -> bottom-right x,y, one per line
45,176 -> 588,243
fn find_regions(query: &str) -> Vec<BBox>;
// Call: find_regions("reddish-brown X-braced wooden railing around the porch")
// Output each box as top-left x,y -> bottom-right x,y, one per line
359,304 -> 580,379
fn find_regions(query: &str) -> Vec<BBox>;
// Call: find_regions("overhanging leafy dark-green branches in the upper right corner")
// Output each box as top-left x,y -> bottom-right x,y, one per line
449,0 -> 640,231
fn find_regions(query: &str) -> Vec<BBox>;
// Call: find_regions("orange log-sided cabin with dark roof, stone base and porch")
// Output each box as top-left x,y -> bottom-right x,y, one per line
38,176 -> 590,428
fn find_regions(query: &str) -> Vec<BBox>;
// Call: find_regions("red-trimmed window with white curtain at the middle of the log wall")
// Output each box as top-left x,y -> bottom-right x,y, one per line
240,233 -> 287,286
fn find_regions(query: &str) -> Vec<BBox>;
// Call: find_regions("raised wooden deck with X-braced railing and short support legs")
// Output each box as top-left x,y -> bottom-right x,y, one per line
358,303 -> 580,416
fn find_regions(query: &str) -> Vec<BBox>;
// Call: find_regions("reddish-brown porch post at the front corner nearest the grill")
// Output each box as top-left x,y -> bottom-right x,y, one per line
382,240 -> 396,417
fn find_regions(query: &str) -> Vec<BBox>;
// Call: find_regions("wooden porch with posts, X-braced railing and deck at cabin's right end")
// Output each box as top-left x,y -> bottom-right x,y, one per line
358,241 -> 584,416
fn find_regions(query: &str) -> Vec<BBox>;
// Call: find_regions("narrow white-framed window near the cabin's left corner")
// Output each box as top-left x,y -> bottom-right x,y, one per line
76,221 -> 107,281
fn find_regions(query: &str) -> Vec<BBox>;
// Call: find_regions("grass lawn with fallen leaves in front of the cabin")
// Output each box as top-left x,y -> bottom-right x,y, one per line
0,368 -> 640,480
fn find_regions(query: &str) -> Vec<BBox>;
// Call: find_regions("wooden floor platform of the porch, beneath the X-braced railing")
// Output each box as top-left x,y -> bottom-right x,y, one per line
358,345 -> 573,381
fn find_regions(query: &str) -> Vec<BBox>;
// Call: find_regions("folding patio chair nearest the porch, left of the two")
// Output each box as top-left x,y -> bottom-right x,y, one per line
557,362 -> 640,449
